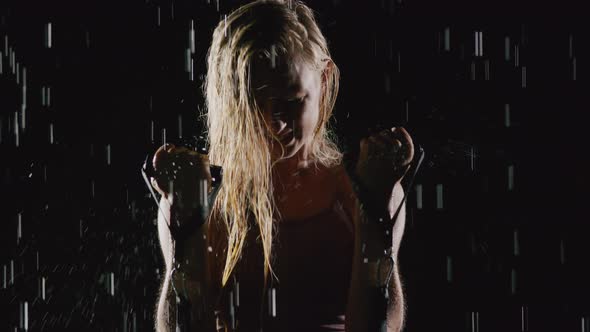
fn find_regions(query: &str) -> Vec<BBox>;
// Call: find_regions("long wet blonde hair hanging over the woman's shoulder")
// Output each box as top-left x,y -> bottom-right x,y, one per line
202,0 -> 342,285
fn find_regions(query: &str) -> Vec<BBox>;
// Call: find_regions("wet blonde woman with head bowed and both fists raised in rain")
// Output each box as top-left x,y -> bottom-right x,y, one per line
152,0 -> 414,331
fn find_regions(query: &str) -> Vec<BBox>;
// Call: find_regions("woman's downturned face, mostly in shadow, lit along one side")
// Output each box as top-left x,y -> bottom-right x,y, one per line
252,56 -> 322,160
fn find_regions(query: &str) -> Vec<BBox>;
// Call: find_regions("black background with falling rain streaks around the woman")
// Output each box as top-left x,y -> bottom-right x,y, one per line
0,0 -> 590,332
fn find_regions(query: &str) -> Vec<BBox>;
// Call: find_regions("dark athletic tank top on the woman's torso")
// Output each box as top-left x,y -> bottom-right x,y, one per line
222,201 -> 354,332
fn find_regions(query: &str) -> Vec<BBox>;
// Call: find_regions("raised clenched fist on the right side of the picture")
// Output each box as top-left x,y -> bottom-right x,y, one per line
356,127 -> 414,208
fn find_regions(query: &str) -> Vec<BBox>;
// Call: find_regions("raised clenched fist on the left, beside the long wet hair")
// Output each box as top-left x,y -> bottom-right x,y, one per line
150,144 -> 212,226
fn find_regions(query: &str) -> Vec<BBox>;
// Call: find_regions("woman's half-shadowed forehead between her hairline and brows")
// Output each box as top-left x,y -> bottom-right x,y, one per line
250,57 -> 319,97
